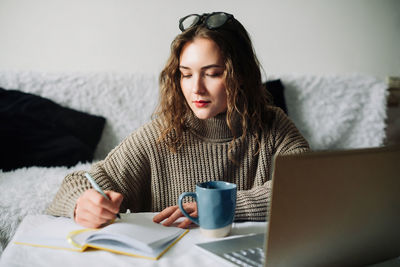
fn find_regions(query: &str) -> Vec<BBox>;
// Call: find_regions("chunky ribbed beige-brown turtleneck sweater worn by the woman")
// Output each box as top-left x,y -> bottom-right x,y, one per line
47,107 -> 309,221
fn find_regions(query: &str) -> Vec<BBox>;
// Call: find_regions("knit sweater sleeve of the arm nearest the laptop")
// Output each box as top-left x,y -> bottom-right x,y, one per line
235,109 -> 309,221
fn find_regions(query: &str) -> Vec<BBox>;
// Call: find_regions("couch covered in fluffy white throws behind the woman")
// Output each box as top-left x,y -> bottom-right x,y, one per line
0,71 -> 388,253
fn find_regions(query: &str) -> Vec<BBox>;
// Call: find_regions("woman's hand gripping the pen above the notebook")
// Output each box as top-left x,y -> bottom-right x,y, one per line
74,189 -> 123,228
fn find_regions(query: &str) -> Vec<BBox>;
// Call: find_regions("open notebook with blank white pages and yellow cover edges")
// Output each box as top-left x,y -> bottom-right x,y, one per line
15,213 -> 188,260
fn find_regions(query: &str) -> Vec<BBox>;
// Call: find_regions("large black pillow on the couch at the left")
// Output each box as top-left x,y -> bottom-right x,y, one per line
0,88 -> 105,171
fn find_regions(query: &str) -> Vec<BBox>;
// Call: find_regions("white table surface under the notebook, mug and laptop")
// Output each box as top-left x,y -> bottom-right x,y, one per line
0,213 -> 267,267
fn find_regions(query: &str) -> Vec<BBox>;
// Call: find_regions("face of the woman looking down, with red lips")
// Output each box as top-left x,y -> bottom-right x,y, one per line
179,38 -> 227,120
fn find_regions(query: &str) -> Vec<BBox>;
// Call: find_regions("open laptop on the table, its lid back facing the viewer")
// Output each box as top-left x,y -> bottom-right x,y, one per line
196,146 -> 400,266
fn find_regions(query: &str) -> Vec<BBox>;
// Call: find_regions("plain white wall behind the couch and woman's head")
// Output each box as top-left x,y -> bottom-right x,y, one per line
0,0 -> 400,77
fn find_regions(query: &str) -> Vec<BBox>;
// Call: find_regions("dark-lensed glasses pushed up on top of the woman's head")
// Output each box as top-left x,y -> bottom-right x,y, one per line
179,12 -> 233,32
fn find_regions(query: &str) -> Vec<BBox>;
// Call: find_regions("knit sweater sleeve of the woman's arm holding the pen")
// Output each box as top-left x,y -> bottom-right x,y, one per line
46,127 -> 150,218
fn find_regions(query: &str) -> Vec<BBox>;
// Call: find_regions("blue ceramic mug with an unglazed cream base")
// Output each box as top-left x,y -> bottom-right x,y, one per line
178,181 -> 237,237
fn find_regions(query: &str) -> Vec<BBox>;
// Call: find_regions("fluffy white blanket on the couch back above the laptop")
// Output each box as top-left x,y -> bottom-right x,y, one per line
279,74 -> 388,150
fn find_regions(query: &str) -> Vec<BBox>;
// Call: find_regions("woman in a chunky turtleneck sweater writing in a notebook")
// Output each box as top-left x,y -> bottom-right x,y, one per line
48,12 -> 309,227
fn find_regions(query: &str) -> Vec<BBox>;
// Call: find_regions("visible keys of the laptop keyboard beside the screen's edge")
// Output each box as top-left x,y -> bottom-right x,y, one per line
222,247 -> 265,267
